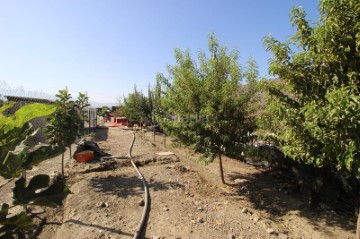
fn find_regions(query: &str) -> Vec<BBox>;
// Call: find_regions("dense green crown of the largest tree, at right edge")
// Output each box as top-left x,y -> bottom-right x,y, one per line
264,0 -> 360,178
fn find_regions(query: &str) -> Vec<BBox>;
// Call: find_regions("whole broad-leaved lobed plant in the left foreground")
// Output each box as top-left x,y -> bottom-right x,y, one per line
0,103 -> 70,239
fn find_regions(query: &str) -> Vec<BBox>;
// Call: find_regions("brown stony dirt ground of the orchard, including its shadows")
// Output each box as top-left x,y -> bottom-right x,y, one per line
0,128 -> 355,239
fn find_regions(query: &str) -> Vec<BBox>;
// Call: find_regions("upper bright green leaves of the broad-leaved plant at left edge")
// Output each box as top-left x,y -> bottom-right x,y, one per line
0,103 -> 63,179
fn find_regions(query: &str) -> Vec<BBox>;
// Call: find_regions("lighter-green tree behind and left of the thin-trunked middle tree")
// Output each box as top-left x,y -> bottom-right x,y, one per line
157,49 -> 204,144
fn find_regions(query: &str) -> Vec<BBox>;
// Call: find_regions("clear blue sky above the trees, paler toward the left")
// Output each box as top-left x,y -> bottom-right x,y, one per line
0,0 -> 319,104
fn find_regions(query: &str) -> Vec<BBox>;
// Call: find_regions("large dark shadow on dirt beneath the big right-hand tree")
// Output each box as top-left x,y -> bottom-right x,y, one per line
228,172 -> 356,233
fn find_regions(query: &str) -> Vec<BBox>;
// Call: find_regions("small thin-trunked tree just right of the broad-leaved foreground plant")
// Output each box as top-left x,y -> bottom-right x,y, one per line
45,89 -> 84,178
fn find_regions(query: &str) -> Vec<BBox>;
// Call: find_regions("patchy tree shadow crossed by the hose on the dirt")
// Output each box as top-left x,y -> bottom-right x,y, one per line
89,175 -> 185,198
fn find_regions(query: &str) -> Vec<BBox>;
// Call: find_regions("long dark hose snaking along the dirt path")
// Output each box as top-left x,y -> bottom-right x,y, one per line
127,132 -> 150,239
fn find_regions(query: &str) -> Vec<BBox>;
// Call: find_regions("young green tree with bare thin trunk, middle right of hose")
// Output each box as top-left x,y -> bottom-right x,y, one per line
198,35 -> 254,183
